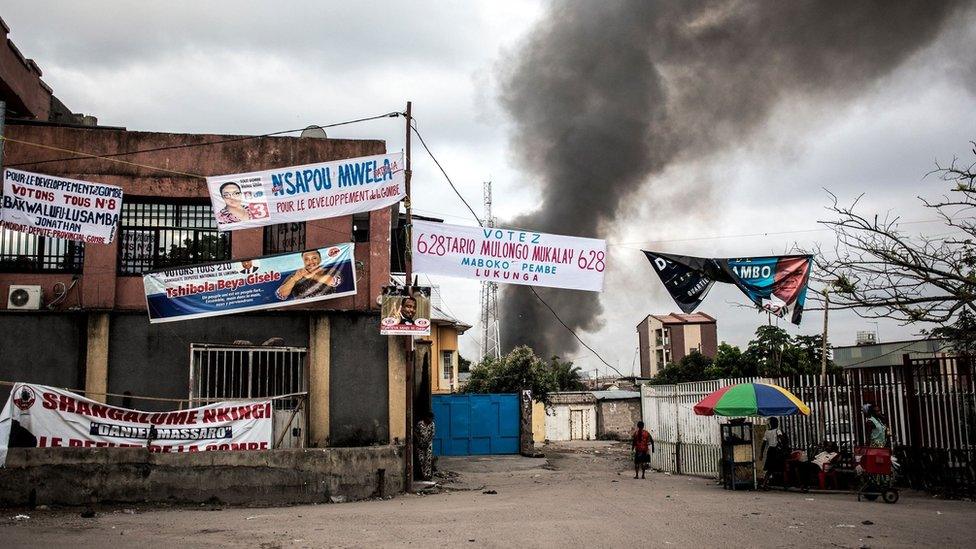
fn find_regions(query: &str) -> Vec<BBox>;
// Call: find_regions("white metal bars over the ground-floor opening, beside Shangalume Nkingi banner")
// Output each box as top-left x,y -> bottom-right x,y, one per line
189,343 -> 308,448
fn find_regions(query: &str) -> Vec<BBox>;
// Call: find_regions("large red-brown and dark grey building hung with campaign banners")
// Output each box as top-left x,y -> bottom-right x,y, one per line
0,25 -> 408,454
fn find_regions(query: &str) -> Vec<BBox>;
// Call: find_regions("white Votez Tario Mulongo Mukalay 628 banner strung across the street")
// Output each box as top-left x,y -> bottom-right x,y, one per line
412,220 -> 607,292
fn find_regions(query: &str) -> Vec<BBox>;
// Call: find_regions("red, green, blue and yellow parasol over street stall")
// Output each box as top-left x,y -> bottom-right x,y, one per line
695,383 -> 810,417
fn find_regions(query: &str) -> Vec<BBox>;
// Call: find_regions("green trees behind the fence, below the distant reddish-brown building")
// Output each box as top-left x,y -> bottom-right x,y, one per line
652,326 -> 837,384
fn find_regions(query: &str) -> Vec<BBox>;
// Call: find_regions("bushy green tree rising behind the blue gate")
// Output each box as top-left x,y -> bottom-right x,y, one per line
464,345 -> 559,404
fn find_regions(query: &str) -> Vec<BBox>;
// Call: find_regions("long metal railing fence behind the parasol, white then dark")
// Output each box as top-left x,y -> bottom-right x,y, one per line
641,355 -> 976,498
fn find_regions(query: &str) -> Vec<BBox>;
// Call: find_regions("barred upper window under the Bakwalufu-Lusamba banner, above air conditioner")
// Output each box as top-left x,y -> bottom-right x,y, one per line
0,228 -> 85,273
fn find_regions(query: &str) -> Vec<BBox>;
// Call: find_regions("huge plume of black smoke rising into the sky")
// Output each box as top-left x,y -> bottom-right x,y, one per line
501,0 -> 972,356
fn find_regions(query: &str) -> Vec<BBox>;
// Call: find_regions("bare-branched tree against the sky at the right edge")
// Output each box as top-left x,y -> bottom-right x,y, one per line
813,142 -> 976,326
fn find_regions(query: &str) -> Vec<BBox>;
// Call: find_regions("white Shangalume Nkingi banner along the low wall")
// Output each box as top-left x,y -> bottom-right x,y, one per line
0,383 -> 273,466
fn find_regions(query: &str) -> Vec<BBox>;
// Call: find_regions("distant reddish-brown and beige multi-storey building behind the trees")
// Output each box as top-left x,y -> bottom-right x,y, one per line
637,313 -> 718,378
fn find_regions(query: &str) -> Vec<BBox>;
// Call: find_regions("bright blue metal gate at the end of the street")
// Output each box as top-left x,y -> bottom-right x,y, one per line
431,395 -> 519,456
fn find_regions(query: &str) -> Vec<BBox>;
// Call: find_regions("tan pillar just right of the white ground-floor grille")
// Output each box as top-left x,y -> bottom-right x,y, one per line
308,313 -> 332,448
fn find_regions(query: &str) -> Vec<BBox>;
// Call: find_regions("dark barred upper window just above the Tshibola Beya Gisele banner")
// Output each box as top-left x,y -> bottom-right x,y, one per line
119,196 -> 231,275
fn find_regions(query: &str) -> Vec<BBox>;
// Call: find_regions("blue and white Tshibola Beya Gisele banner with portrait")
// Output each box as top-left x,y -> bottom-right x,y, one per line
142,243 -> 356,323
